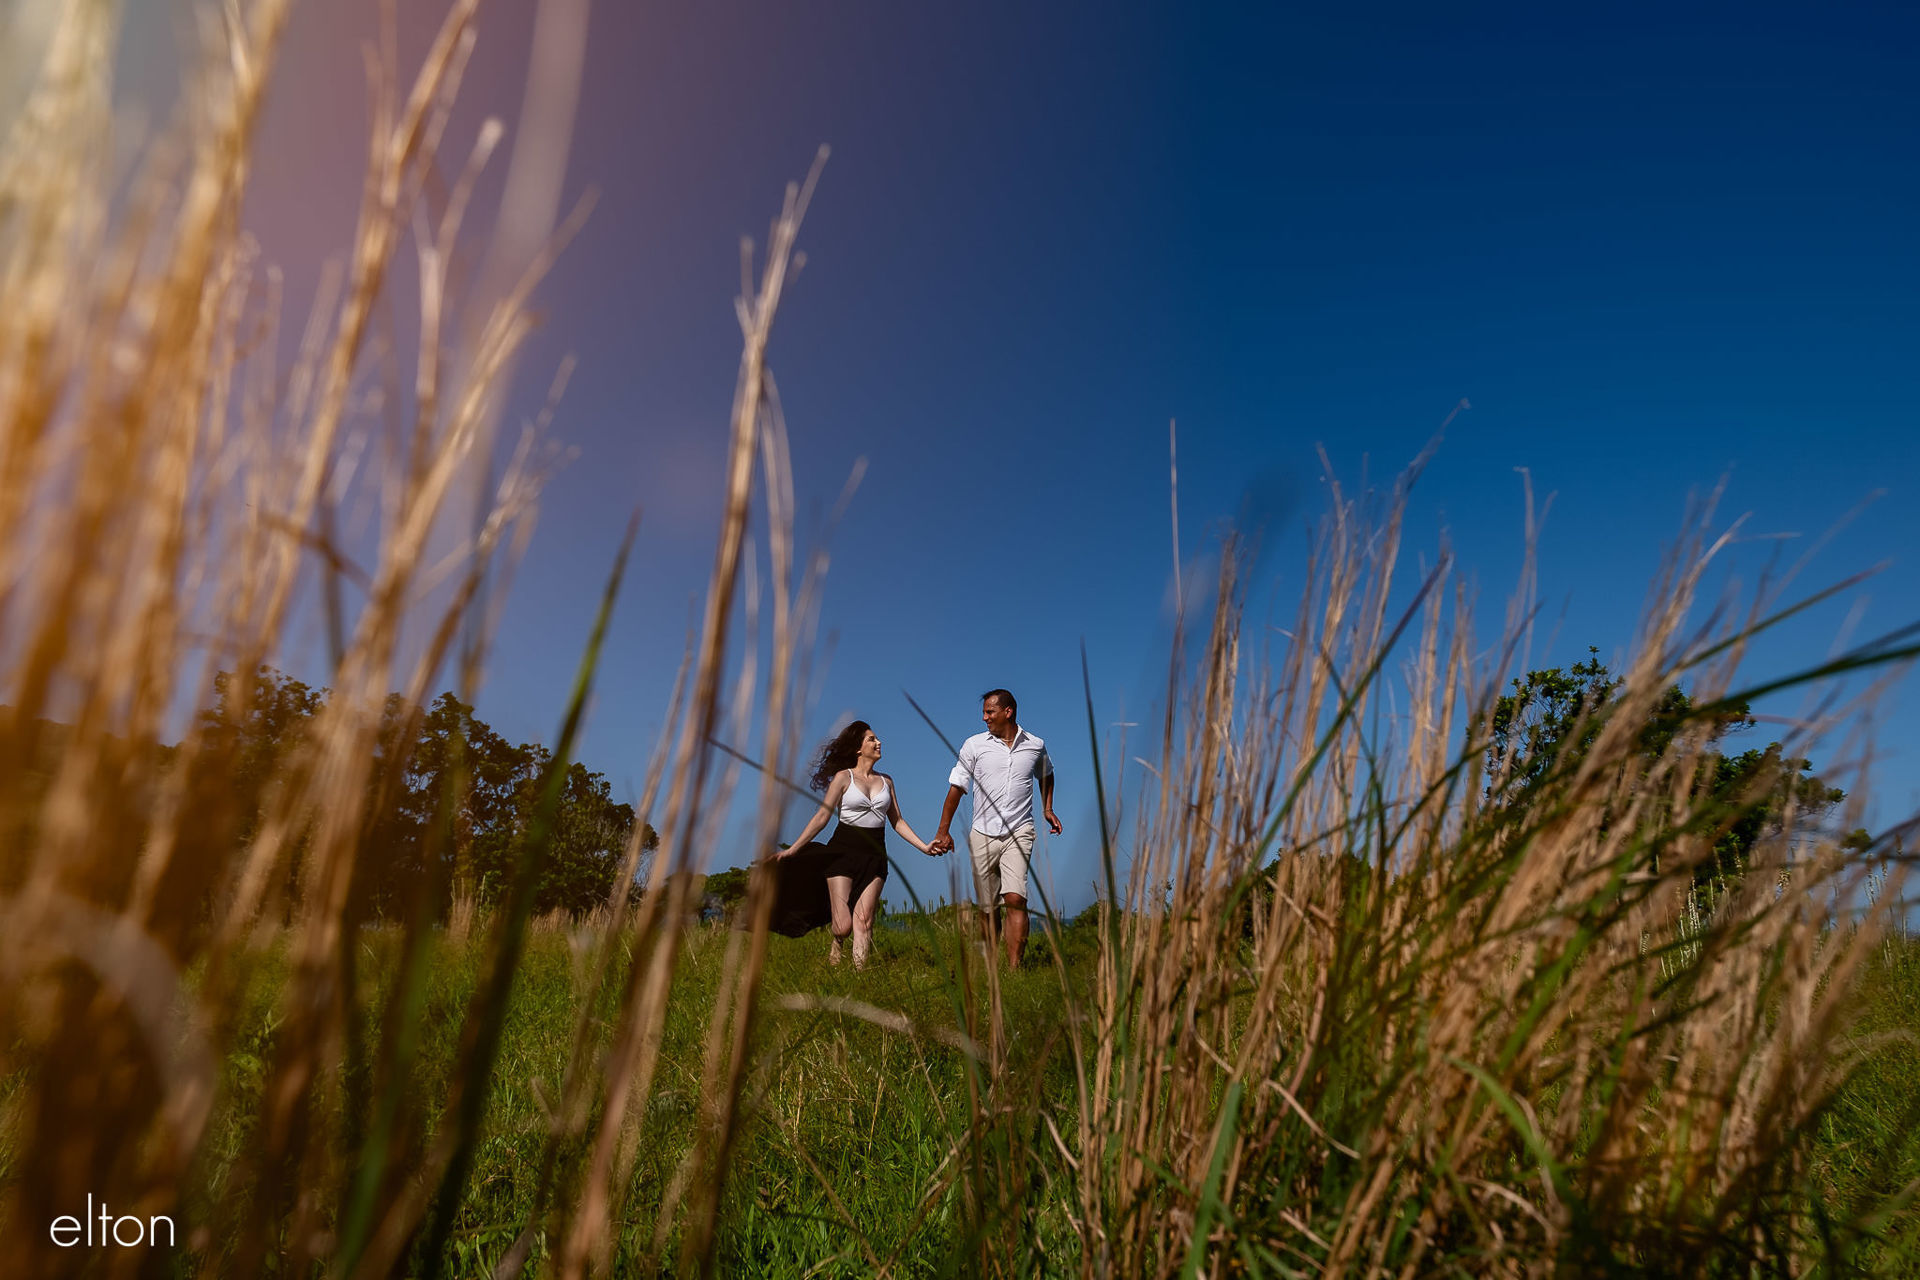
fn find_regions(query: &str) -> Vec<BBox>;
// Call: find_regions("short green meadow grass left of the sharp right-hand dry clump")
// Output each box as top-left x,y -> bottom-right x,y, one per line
0,915 -> 1098,1276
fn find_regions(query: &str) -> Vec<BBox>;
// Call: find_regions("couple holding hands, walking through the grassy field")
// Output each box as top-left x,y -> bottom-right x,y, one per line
774,689 -> 1060,969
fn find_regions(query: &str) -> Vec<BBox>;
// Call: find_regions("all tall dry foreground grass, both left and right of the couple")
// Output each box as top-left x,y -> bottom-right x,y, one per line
0,0 -> 1910,1276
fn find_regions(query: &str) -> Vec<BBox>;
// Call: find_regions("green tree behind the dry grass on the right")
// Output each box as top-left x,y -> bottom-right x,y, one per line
1486,649 -> 1862,883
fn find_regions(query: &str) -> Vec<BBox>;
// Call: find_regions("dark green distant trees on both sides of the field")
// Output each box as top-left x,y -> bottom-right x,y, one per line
0,656 -> 1866,932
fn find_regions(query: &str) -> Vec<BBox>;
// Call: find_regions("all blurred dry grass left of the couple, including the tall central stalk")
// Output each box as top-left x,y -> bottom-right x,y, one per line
0,0 -> 848,1276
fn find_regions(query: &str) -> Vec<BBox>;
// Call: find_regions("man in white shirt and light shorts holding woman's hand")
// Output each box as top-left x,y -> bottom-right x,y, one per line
929,689 -> 1060,969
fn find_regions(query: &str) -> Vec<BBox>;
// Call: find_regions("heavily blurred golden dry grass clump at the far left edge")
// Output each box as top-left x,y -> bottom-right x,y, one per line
0,0 -> 583,1274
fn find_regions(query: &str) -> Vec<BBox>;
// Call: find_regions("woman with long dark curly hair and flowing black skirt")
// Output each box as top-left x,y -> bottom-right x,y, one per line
776,720 -> 933,969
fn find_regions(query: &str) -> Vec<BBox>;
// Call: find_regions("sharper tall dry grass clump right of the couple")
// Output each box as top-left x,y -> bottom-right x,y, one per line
1013,464 -> 1914,1276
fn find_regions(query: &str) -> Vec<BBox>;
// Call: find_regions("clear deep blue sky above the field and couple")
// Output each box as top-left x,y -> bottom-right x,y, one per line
180,0 -> 1920,906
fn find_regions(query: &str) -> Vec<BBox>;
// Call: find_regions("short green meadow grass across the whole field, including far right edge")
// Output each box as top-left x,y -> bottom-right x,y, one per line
90,917 -> 1920,1276
